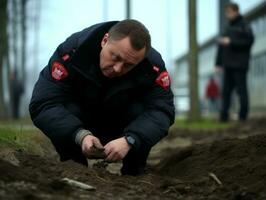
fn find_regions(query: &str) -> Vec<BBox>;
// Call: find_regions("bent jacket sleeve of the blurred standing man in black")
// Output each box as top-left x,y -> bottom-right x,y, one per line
230,25 -> 254,48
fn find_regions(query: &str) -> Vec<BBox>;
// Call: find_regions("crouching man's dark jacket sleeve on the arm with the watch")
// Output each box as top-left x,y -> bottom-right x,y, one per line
125,85 -> 175,148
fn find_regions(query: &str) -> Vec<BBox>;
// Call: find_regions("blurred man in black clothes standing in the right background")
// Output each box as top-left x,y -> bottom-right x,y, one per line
216,3 -> 254,122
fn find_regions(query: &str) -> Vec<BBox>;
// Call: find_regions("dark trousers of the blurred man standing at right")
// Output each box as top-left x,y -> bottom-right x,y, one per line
220,68 -> 249,121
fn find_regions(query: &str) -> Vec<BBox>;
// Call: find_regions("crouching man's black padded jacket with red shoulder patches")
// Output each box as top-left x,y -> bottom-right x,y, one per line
29,22 -> 175,160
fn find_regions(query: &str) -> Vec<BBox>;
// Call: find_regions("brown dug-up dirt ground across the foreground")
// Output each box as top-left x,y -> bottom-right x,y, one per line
0,118 -> 266,200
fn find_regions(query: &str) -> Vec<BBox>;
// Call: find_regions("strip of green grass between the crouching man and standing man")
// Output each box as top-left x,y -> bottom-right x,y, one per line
173,119 -> 232,130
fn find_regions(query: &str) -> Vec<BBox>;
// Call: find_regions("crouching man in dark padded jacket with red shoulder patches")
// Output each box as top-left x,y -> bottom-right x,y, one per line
29,20 -> 175,175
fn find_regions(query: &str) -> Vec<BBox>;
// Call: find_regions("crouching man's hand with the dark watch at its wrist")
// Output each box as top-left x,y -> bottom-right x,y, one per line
104,137 -> 131,162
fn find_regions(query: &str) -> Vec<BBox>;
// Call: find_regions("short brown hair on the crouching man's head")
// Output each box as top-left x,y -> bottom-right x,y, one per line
108,19 -> 151,53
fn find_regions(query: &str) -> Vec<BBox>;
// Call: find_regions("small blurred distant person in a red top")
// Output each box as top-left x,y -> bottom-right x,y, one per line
205,77 -> 220,113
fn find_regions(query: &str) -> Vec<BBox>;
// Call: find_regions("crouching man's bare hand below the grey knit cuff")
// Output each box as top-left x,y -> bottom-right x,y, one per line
81,135 -> 106,158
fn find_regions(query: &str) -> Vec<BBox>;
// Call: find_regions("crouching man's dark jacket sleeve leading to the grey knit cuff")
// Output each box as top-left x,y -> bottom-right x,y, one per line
29,46 -> 83,158
